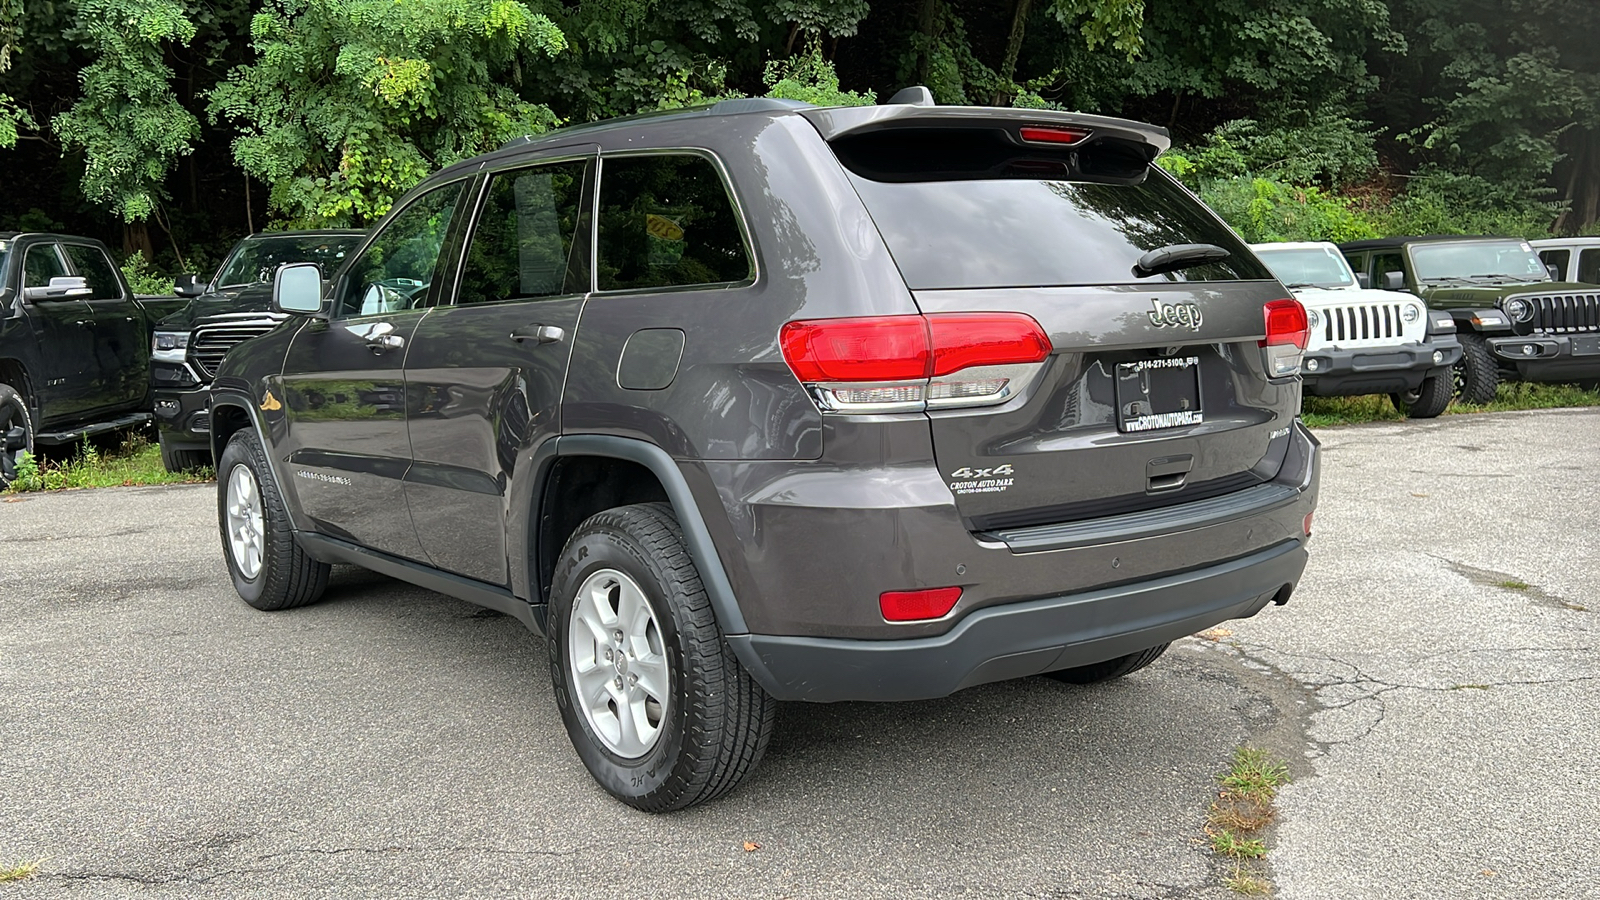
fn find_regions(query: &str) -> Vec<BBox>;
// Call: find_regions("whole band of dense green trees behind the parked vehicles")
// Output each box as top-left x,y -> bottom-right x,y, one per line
0,0 -> 1600,274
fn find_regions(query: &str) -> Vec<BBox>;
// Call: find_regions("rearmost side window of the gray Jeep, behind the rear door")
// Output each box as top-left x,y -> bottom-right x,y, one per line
595,154 -> 754,290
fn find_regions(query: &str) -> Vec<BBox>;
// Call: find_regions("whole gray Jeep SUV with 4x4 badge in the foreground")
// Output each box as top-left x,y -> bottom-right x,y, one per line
211,91 -> 1318,812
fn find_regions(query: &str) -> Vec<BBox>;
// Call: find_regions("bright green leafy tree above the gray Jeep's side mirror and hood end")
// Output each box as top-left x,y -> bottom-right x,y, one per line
211,0 -> 566,226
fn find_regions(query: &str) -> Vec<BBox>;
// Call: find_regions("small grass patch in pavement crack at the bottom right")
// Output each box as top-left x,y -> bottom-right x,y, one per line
1205,746 -> 1290,895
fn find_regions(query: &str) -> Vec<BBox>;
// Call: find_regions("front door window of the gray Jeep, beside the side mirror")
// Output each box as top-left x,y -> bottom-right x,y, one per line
334,181 -> 462,317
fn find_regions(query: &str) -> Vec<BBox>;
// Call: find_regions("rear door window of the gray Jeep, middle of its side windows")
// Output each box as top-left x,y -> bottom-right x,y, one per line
456,160 -> 589,304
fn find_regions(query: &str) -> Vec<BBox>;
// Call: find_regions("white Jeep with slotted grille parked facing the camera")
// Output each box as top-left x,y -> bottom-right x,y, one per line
1251,240 -> 1461,418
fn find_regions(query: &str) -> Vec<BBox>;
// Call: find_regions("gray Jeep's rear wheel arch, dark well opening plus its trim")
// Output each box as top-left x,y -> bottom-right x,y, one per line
530,434 -> 749,634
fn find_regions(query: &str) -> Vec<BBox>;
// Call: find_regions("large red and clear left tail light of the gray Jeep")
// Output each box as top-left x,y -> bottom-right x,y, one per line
779,312 -> 1051,413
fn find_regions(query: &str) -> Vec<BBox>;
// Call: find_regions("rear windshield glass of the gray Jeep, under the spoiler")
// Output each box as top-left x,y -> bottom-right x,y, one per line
834,128 -> 1272,290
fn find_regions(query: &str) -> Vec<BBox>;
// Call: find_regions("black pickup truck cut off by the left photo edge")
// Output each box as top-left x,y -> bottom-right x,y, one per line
0,232 -> 173,488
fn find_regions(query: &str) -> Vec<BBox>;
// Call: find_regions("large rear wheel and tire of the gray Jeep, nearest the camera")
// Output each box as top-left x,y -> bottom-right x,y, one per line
546,503 -> 778,812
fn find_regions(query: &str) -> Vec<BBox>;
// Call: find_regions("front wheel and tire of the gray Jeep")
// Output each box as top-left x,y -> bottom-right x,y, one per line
216,429 -> 328,610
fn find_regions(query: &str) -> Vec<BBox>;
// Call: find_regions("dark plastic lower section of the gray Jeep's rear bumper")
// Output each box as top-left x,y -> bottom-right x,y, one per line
730,540 -> 1306,701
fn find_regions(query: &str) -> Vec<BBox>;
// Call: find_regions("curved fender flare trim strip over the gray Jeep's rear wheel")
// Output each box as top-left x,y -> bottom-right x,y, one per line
555,434 -> 750,630
